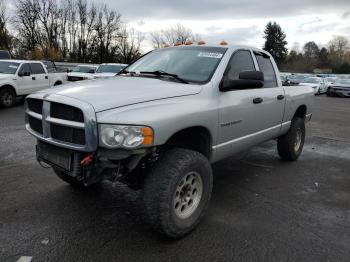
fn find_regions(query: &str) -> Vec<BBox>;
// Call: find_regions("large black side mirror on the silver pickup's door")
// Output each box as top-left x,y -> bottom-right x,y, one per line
220,71 -> 264,92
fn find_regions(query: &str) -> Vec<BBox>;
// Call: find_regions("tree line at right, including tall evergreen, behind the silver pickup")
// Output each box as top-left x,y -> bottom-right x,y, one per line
263,22 -> 350,74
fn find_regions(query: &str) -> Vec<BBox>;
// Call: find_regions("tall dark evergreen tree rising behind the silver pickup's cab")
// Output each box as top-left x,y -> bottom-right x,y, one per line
263,22 -> 288,65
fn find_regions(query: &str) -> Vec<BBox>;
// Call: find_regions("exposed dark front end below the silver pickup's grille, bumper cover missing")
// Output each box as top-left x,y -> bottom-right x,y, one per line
36,140 -> 155,186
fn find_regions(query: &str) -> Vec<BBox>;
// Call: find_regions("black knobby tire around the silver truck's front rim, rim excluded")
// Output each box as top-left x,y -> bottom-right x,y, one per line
143,148 -> 213,239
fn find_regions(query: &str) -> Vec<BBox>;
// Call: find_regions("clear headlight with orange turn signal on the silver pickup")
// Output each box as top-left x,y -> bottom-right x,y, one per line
99,124 -> 153,148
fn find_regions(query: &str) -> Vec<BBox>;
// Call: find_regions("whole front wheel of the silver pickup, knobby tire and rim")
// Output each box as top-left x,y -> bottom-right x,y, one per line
143,149 -> 213,238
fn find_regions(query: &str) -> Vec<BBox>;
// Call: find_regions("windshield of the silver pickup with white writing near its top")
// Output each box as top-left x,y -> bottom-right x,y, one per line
127,46 -> 227,83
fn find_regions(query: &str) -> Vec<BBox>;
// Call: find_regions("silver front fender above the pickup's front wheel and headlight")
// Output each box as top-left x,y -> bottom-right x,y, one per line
97,94 -> 218,146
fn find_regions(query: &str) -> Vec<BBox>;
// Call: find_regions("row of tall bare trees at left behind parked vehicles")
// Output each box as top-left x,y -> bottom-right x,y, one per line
0,0 -> 144,63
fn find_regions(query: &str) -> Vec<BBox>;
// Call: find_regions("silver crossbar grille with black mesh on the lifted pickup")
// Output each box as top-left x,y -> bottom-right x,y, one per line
26,98 -> 97,151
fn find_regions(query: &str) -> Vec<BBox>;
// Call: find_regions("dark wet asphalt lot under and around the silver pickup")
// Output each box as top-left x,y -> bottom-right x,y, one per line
0,96 -> 350,262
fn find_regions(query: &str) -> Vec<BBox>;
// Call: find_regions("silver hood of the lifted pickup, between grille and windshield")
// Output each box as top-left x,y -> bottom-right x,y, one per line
39,76 -> 201,112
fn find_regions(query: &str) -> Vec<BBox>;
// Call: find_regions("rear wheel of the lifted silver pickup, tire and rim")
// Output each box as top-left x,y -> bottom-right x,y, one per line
277,117 -> 305,161
